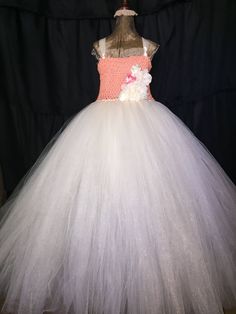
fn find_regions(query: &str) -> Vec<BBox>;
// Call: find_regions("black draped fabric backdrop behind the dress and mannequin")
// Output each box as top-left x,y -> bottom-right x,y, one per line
0,0 -> 236,193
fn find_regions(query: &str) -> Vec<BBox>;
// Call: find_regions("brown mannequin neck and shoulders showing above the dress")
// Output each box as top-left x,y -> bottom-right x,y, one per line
92,1 -> 160,59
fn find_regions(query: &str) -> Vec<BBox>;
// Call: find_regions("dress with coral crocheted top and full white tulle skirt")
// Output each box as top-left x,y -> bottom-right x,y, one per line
0,40 -> 236,314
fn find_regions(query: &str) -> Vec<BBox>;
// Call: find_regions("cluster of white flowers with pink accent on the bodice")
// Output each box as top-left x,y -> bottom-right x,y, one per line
118,64 -> 152,101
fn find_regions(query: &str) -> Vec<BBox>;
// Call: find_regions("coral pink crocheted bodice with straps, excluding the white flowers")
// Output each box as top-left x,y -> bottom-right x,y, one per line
97,38 -> 153,100
